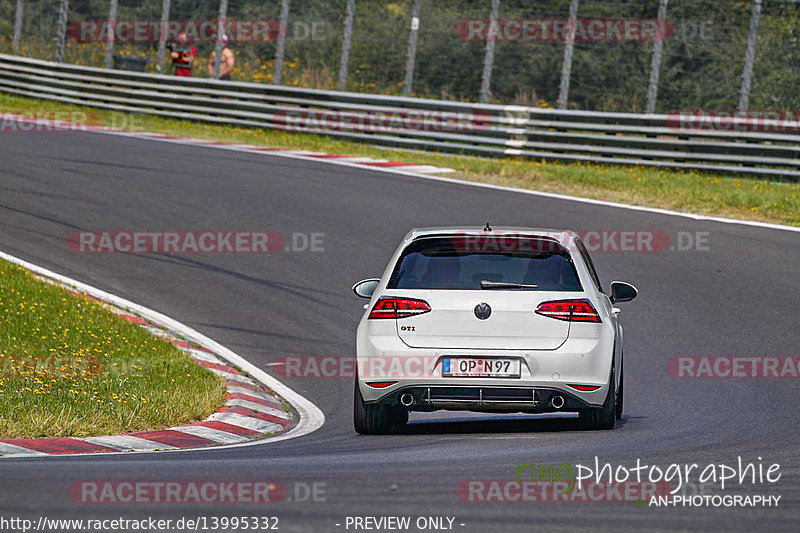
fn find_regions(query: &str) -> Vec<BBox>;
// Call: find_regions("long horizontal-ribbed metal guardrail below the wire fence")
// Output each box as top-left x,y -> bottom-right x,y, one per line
0,54 -> 800,180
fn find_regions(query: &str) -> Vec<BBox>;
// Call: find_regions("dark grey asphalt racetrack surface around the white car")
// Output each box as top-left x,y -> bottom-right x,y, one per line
0,132 -> 800,532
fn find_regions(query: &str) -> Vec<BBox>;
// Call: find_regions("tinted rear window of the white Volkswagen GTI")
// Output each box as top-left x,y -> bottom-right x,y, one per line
388,236 -> 582,291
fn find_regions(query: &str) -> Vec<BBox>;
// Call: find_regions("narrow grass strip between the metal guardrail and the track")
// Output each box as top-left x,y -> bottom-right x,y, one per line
0,94 -> 800,226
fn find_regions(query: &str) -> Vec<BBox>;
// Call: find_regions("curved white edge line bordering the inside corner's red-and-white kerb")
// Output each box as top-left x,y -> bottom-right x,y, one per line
0,251 -> 325,457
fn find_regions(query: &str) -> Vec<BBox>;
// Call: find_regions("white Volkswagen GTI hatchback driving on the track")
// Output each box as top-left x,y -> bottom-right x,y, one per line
353,224 -> 637,434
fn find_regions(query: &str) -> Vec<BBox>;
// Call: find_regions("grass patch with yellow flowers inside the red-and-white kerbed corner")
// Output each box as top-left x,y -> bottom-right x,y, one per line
0,260 -> 226,438
